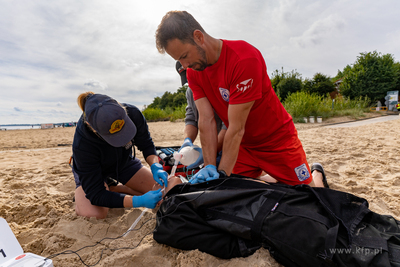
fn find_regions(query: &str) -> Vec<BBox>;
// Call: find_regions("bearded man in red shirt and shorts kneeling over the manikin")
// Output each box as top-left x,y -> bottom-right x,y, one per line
156,11 -> 327,186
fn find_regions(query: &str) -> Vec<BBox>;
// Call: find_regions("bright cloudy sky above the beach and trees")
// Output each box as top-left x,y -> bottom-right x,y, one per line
0,0 -> 400,124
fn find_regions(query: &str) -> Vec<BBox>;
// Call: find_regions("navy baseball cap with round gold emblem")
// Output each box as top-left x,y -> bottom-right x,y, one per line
85,94 -> 136,147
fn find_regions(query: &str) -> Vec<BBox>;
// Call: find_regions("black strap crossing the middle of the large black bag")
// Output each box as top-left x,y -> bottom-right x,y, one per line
251,191 -> 286,242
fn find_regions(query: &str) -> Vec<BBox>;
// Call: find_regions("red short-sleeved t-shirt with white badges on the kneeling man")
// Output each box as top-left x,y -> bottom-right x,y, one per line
187,40 -> 296,148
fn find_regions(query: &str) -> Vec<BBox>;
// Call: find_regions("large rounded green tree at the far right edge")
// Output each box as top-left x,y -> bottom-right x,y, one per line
340,51 -> 399,101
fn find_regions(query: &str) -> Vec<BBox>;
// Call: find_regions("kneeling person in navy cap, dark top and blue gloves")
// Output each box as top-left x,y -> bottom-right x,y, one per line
72,92 -> 168,218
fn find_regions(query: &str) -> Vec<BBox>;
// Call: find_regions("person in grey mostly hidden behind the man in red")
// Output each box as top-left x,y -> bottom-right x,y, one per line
175,61 -> 226,169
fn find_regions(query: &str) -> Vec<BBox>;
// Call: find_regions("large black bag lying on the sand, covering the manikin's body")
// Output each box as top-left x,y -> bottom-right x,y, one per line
153,178 -> 400,267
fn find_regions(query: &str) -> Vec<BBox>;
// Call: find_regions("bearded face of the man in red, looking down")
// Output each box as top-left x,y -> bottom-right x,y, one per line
165,39 -> 208,71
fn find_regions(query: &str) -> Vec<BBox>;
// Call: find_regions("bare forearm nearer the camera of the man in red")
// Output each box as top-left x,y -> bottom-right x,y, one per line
218,101 -> 254,176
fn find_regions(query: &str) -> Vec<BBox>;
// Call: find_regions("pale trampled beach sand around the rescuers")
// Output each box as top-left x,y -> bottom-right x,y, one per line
0,117 -> 400,267
